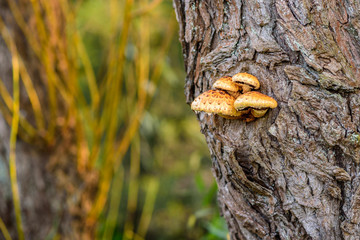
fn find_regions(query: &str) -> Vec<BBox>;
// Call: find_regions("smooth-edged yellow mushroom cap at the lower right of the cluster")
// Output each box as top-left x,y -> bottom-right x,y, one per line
234,92 -> 277,111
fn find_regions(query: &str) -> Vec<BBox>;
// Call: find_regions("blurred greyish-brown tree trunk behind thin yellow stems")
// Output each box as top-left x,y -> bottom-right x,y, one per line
0,0 -> 94,239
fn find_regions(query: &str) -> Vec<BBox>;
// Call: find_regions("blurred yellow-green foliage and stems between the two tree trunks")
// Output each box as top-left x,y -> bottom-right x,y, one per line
0,0 -> 227,239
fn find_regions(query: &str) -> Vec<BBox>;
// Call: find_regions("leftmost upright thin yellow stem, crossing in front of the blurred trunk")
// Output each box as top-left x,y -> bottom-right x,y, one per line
9,50 -> 24,240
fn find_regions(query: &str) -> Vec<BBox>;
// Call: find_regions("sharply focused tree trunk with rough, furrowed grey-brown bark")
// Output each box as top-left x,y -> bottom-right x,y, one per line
174,0 -> 360,240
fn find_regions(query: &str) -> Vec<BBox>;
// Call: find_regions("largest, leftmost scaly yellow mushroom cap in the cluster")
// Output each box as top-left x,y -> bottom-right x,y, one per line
191,90 -> 243,117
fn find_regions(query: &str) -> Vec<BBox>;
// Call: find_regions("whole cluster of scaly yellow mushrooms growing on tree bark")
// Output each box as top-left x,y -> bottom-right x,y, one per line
191,73 -> 277,122
